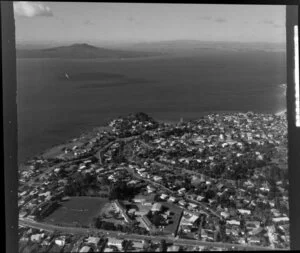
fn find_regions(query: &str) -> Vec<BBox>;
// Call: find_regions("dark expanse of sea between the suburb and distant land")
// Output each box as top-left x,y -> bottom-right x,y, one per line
17,51 -> 286,162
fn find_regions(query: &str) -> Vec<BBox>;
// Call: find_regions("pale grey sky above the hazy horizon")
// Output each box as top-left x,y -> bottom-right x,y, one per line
14,2 -> 285,44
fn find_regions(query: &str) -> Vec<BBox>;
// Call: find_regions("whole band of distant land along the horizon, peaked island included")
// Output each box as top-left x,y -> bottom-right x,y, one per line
16,40 -> 285,59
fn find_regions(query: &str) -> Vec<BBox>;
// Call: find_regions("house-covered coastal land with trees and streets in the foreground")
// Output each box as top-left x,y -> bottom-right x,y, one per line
18,112 -> 289,253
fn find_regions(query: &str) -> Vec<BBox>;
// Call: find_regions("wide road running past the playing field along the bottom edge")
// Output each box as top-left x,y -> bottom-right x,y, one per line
19,219 -> 279,250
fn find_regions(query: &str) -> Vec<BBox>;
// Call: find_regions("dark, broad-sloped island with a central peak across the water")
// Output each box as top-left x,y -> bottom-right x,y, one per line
16,43 -> 159,59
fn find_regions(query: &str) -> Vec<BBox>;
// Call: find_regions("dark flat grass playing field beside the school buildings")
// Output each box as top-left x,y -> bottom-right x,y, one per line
44,197 -> 109,226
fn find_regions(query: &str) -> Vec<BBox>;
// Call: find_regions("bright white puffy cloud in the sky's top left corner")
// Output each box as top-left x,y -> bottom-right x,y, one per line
14,1 -> 53,18
